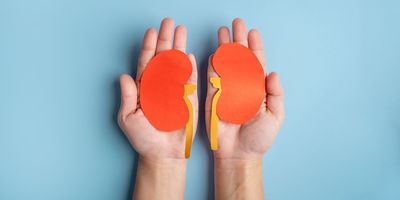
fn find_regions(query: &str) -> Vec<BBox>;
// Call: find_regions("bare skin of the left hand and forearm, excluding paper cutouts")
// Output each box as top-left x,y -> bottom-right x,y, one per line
118,18 -> 198,200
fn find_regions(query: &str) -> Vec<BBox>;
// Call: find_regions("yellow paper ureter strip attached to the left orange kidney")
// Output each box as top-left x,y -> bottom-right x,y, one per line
183,84 -> 196,158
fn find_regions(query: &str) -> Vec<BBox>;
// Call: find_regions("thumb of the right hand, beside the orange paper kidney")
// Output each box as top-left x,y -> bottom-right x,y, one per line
266,72 -> 285,122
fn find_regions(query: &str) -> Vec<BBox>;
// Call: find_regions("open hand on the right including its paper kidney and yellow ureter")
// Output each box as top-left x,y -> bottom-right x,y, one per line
206,18 -> 284,160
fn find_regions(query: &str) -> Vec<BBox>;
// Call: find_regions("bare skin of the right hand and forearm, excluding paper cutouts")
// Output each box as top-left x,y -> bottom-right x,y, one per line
205,18 -> 284,200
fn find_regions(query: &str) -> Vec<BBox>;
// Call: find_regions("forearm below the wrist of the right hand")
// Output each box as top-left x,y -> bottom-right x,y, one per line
214,159 -> 264,200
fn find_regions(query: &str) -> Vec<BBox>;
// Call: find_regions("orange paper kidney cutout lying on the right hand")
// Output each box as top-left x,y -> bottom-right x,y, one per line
212,43 -> 265,124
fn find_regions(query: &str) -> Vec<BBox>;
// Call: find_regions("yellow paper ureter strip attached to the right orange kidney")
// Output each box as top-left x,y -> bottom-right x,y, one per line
210,77 -> 222,151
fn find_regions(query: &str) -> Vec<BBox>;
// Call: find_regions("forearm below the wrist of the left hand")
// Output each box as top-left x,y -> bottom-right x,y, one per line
133,158 -> 186,200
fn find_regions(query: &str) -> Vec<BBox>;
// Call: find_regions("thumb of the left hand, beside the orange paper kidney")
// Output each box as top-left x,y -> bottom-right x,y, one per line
119,74 -> 137,119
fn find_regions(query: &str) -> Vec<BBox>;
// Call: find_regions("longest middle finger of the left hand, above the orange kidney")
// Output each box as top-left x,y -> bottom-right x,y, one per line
156,18 -> 174,53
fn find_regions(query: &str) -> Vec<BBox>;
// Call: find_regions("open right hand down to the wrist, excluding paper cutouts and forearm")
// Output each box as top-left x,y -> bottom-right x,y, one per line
205,19 -> 284,160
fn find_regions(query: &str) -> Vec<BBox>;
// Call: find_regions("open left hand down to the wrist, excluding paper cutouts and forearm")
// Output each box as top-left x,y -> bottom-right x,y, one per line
118,18 -> 198,160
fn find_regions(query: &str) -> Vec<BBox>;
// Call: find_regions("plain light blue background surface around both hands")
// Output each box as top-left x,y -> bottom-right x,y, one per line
0,0 -> 400,200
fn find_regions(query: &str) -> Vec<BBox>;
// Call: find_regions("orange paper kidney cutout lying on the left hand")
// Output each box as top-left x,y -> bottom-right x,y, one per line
139,50 -> 192,131
